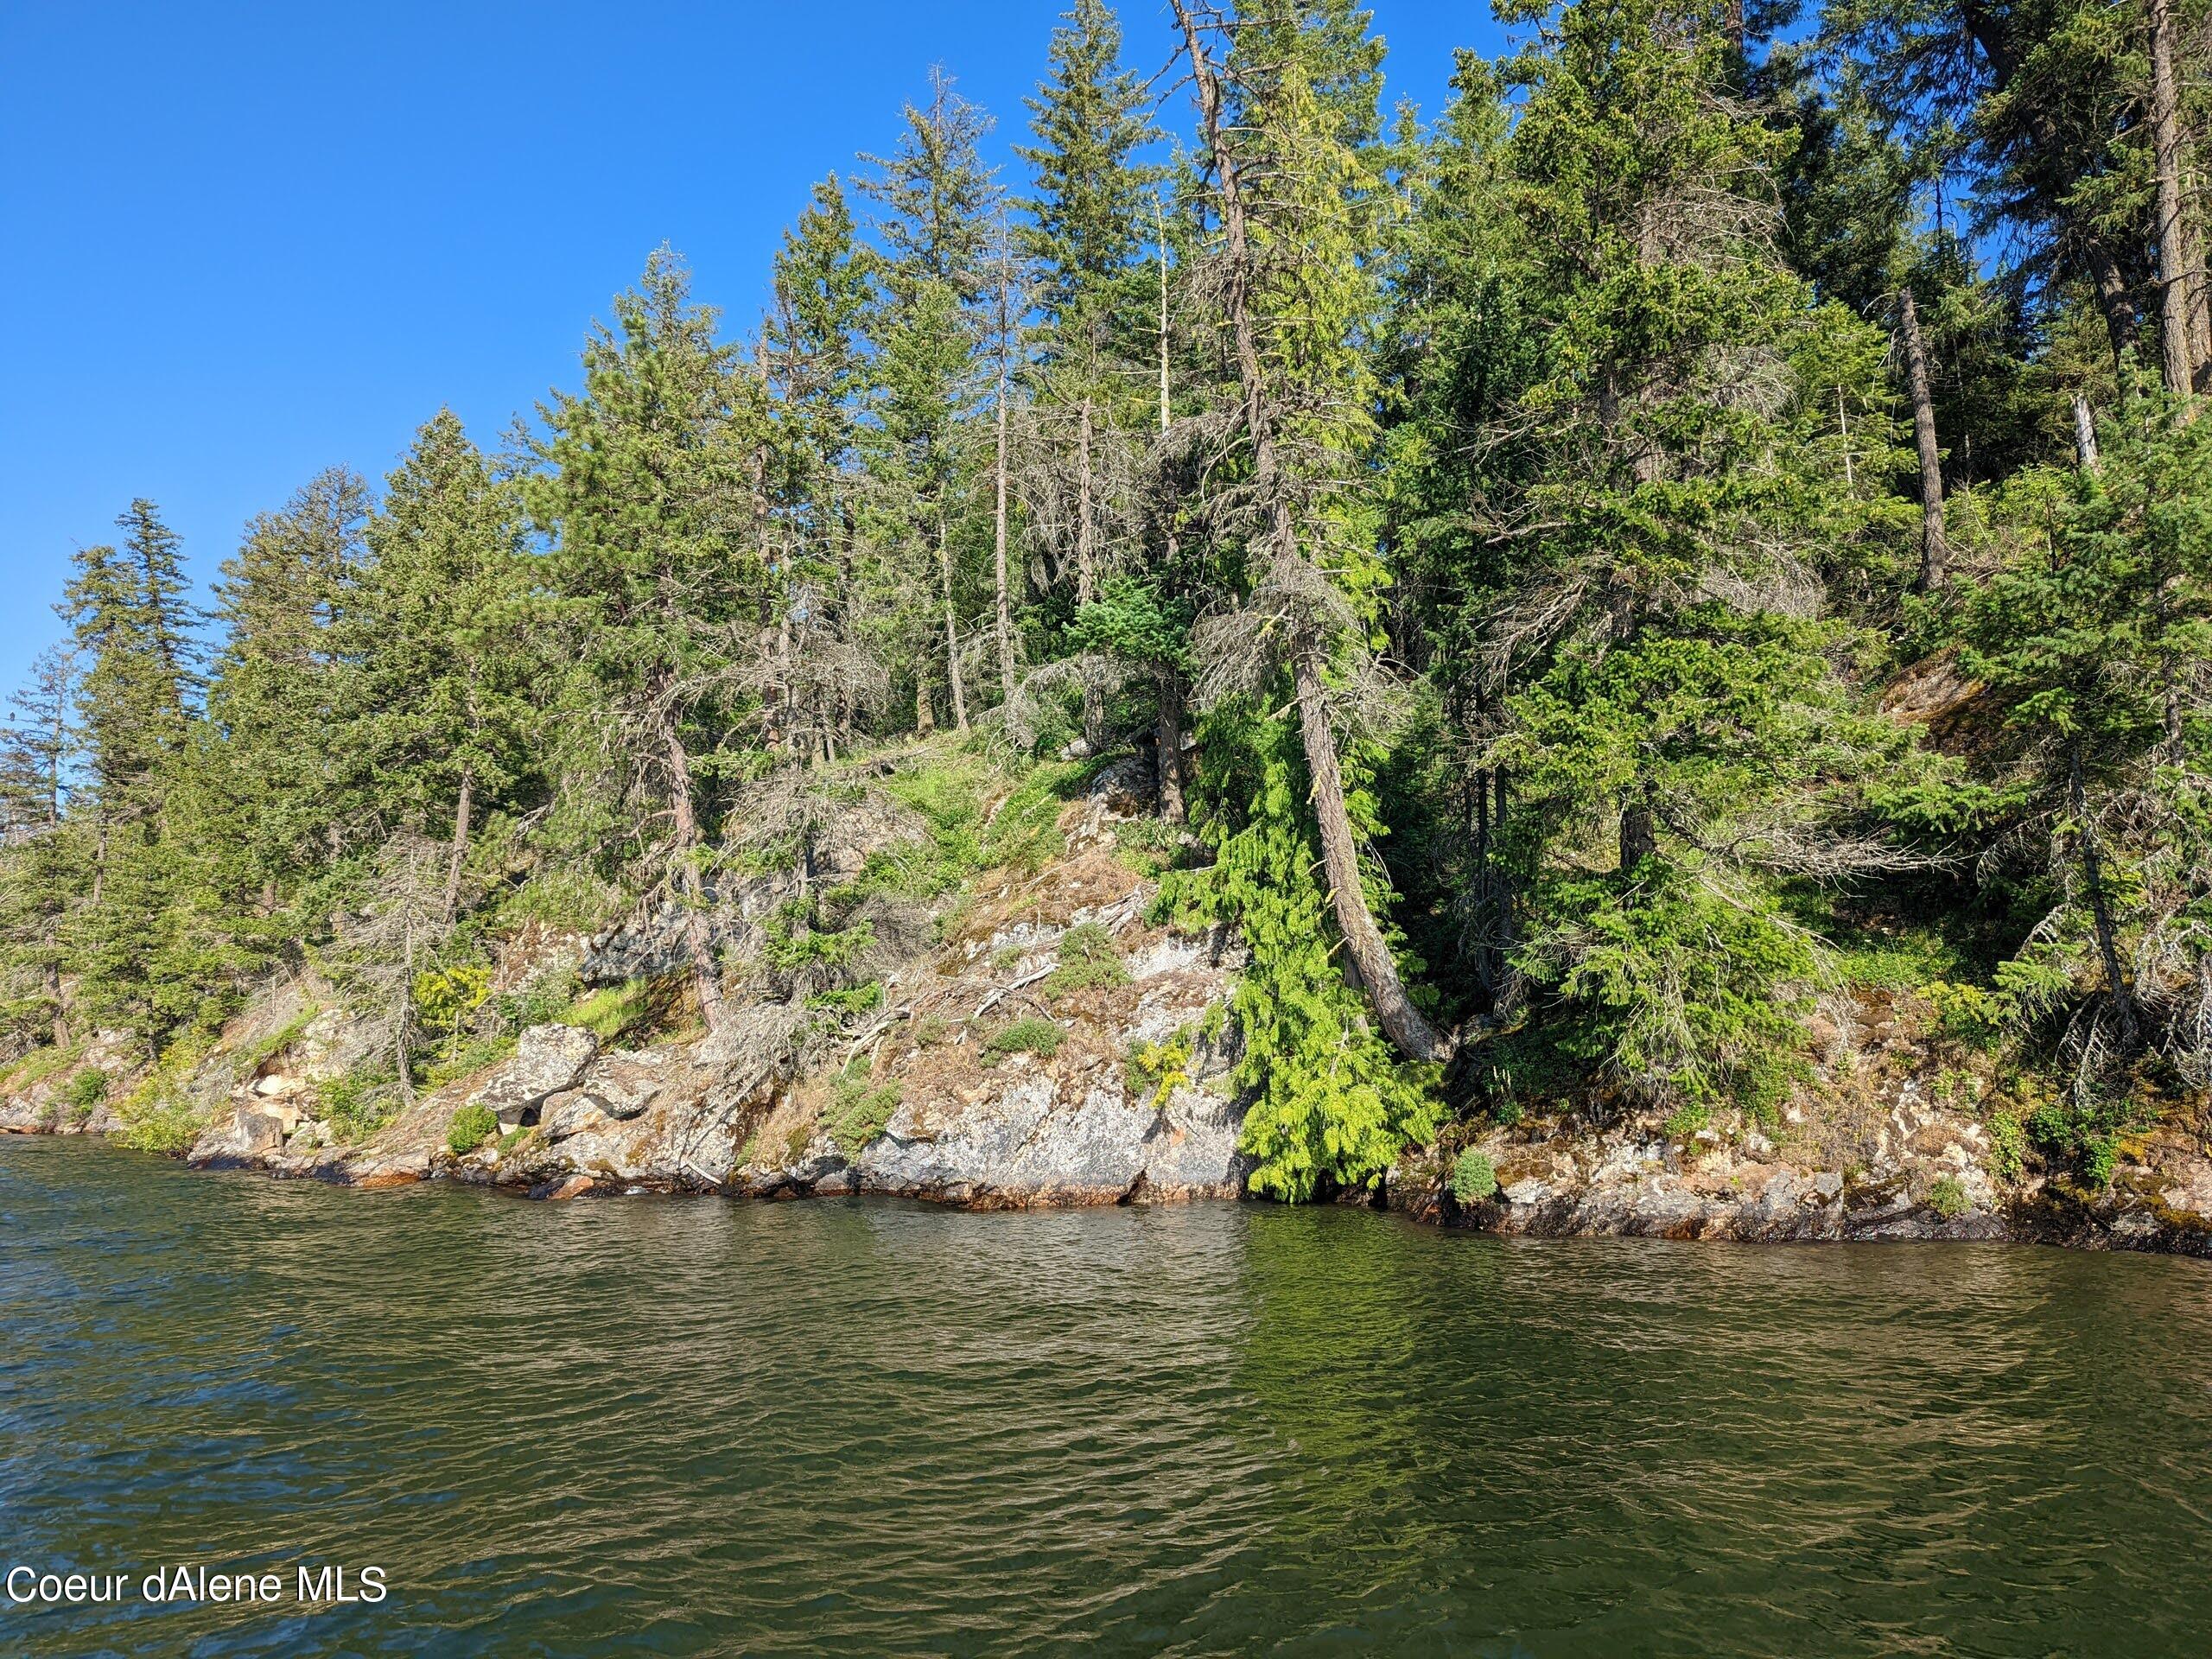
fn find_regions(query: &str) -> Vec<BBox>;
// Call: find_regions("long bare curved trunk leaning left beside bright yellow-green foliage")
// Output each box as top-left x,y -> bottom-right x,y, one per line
1174,0 -> 1451,1059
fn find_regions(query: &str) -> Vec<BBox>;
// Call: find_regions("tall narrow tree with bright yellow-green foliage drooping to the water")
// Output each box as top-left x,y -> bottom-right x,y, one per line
1177,0 -> 1449,1197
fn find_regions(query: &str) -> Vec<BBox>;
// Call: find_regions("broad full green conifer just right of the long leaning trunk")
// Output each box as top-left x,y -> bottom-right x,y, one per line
1478,0 -> 1903,1110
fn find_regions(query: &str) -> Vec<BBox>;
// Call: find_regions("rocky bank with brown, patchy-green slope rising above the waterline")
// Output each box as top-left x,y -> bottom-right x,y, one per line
0,774 -> 2212,1256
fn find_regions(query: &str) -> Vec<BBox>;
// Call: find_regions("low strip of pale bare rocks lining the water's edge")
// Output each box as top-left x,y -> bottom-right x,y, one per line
0,1026 -> 2212,1259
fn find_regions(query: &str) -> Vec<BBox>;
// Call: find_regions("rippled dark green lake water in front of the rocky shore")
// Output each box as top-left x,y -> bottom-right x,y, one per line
0,1139 -> 2212,1659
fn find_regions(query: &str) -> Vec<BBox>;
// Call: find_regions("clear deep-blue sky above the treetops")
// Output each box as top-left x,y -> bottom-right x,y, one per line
0,0 -> 1502,695
